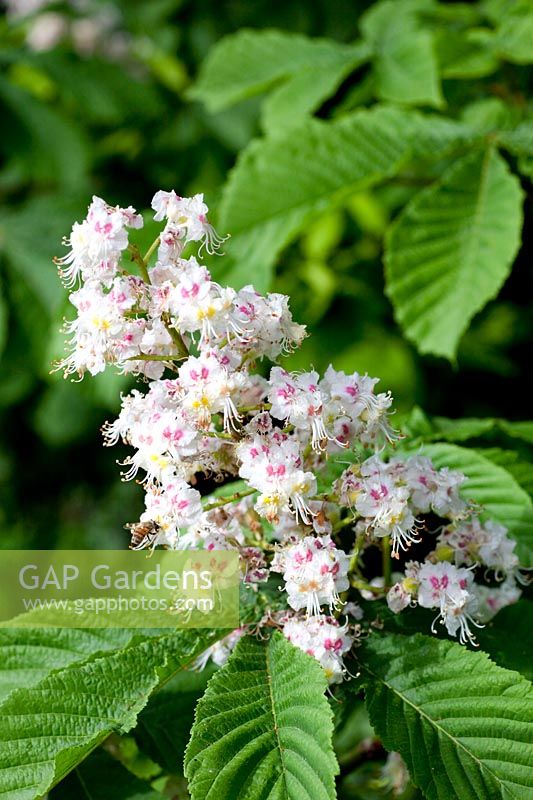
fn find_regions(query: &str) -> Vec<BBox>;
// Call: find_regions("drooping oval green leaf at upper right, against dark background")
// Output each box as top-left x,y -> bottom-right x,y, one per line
385,148 -> 523,359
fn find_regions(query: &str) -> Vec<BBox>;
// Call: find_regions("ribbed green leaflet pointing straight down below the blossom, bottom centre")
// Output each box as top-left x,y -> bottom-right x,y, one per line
185,633 -> 337,800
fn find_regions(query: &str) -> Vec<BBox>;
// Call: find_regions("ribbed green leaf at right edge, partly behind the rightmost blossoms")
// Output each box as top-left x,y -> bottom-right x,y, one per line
417,444 -> 533,567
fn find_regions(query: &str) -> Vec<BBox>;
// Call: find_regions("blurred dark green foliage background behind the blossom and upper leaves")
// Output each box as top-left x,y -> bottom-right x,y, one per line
0,0 -> 533,547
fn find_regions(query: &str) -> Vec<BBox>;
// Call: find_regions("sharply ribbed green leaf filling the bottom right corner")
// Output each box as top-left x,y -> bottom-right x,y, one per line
359,634 -> 533,800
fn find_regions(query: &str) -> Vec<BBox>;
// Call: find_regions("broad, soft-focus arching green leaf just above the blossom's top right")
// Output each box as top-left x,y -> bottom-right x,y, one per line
219,107 -> 473,291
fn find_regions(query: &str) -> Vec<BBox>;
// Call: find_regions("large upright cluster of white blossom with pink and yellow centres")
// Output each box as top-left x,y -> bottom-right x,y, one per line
58,191 -> 519,682
